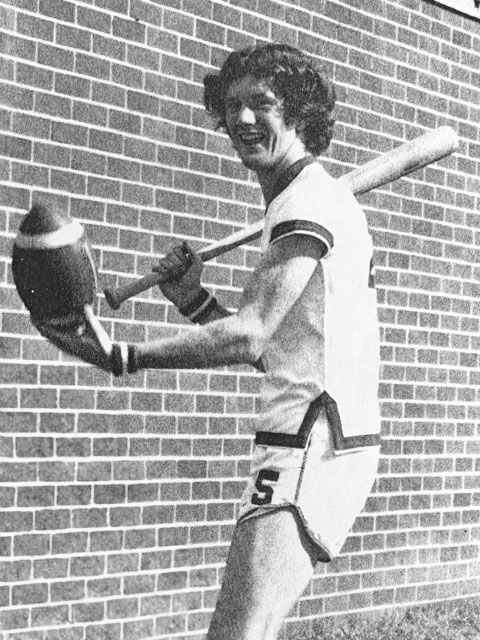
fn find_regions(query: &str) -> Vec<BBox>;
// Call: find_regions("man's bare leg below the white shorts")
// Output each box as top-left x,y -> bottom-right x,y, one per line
207,508 -> 317,640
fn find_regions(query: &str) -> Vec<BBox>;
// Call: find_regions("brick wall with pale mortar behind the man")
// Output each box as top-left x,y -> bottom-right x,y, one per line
0,0 -> 480,640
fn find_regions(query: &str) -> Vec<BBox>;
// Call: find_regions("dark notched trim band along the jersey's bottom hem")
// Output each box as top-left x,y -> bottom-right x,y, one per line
255,391 -> 380,451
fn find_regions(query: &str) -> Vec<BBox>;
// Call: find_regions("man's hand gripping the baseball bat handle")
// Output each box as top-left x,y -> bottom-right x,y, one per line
152,242 -> 203,307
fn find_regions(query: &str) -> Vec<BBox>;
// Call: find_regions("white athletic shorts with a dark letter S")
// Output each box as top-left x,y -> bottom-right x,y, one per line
238,411 -> 380,562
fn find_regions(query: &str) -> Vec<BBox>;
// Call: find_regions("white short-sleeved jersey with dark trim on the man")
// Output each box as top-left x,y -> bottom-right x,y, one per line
256,162 -> 380,452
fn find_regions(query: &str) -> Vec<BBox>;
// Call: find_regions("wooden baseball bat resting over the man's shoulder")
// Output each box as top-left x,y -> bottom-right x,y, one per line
104,126 -> 459,309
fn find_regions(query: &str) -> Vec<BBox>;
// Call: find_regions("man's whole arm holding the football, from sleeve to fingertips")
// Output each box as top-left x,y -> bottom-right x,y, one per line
32,236 -> 321,375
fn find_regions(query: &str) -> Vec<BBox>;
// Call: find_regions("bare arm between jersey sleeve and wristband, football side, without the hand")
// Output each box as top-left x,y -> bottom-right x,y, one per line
137,236 -> 318,369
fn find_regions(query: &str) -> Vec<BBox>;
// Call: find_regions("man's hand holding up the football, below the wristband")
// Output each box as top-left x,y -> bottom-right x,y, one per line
31,305 -> 113,372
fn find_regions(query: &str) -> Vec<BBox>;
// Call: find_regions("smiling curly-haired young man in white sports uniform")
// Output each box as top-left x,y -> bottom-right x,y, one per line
37,44 -> 380,640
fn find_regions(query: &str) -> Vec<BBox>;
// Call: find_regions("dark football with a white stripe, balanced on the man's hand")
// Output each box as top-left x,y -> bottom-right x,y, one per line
12,204 -> 97,320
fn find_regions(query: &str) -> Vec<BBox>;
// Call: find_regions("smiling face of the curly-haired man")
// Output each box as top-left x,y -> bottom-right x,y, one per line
225,75 -> 305,179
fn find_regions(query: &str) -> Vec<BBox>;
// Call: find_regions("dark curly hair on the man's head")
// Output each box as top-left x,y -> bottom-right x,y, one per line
204,43 -> 336,155
